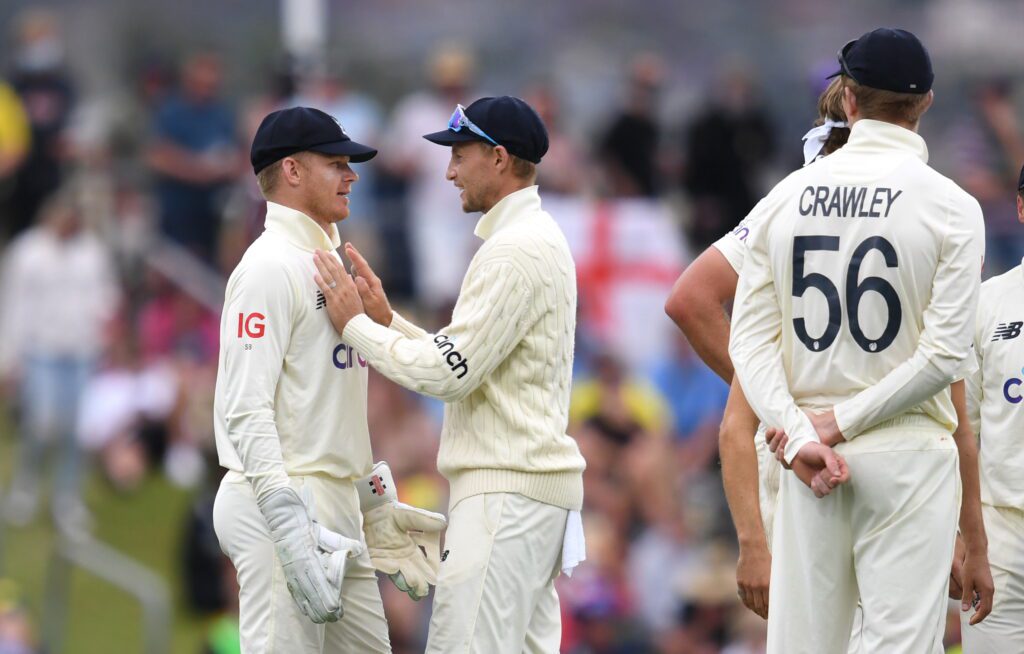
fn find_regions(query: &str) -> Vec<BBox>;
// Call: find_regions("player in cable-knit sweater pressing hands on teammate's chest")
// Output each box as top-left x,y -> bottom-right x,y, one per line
316,96 -> 585,654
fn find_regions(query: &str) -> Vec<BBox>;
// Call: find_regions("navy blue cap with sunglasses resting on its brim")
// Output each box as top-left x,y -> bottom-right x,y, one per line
423,95 -> 548,164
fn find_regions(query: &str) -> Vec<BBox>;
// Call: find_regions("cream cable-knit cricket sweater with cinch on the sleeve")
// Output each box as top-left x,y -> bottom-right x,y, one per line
344,186 -> 586,510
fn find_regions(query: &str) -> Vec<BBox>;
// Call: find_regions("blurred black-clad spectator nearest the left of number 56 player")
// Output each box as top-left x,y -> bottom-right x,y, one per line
682,70 -> 775,252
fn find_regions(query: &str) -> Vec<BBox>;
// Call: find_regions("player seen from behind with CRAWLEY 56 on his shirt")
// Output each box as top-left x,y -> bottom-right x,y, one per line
729,29 -> 984,654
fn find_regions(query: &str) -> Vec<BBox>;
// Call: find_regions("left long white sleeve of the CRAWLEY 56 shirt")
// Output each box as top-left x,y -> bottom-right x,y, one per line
729,212 -> 820,462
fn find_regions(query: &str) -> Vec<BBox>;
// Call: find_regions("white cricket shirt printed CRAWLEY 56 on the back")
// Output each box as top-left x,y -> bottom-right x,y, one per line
729,120 -> 984,461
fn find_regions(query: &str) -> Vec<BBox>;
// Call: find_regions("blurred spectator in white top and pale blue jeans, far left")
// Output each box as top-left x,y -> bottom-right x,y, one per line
0,188 -> 119,531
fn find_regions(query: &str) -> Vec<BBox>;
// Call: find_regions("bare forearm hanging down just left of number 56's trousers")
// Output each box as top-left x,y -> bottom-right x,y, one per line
719,381 -> 768,548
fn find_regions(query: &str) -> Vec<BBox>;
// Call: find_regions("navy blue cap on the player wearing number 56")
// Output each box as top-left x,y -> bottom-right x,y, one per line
828,28 -> 935,93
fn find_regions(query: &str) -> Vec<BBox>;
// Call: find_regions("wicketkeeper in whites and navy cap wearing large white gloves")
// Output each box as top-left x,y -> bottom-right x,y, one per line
213,107 -> 444,654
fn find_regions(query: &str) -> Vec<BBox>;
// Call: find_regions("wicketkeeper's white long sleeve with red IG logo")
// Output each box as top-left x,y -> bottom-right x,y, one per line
220,264 -> 293,497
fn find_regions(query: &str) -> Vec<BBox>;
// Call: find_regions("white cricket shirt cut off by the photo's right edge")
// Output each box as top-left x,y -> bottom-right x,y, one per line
967,266 -> 1024,511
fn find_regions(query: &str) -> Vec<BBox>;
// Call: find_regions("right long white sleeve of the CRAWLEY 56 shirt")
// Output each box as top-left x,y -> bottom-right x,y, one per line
836,199 -> 984,439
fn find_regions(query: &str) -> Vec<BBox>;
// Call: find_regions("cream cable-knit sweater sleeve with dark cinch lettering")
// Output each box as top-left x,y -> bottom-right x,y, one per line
342,259 -> 534,402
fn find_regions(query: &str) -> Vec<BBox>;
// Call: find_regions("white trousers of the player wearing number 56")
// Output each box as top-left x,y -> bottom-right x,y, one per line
768,415 -> 959,654
